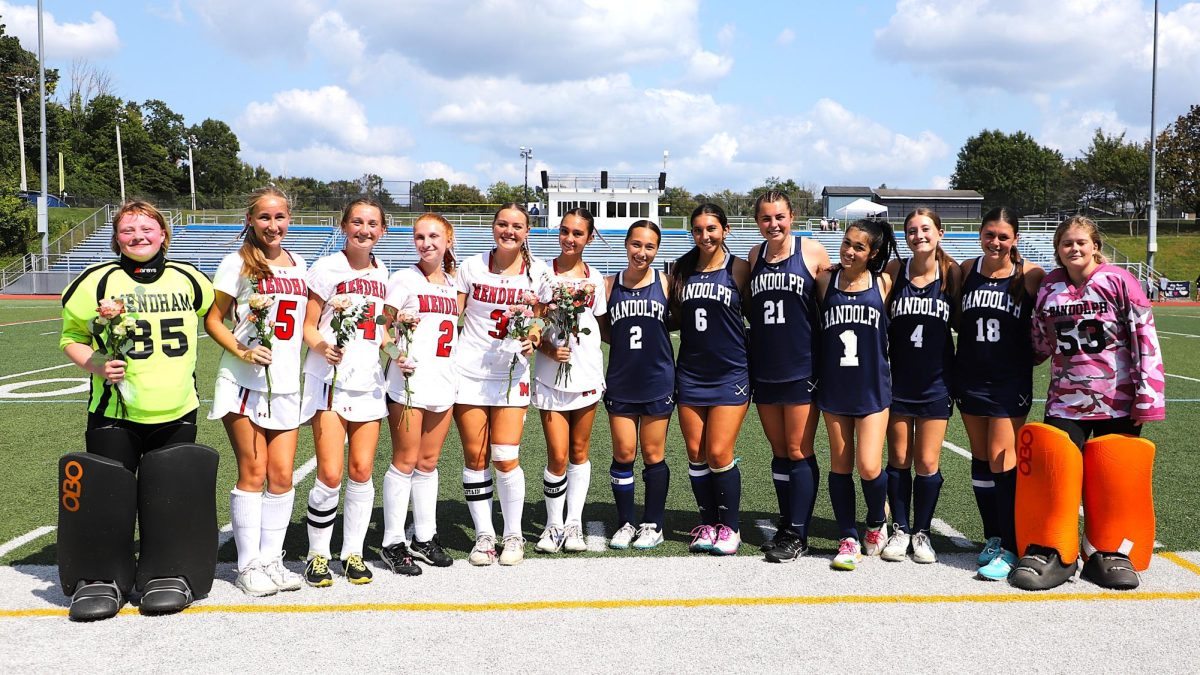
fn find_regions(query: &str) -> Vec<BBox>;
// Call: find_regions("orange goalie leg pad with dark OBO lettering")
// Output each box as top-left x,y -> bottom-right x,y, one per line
1015,422 -> 1084,565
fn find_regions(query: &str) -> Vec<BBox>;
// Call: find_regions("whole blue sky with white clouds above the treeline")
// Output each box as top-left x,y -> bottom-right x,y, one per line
0,0 -> 1200,192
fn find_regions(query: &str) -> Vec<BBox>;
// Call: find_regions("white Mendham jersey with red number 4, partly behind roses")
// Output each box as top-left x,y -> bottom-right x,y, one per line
304,251 -> 388,392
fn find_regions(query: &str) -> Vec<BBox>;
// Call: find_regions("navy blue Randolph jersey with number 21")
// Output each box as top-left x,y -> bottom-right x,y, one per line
746,237 -> 817,382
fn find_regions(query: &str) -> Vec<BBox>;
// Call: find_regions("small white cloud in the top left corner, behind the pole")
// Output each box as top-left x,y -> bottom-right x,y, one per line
0,0 -> 121,60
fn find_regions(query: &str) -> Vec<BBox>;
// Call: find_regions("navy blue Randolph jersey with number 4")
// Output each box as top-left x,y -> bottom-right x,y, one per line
888,261 -> 954,404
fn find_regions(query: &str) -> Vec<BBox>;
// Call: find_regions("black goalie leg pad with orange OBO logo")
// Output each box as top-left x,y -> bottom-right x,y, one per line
58,453 -> 138,596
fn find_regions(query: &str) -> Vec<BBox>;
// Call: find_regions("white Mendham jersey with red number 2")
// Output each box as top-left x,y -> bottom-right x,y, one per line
385,265 -> 458,405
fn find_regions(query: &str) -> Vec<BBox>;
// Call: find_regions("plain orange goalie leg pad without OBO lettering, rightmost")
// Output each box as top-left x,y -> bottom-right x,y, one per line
1084,434 -> 1154,572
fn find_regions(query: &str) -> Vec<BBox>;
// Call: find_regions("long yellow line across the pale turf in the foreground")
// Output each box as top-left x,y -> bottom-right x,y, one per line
7,591 -> 1200,619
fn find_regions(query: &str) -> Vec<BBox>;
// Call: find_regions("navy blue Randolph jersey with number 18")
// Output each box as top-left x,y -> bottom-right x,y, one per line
954,258 -> 1034,396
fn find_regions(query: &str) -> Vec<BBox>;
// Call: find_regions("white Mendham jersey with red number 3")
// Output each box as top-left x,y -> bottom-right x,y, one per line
455,252 -> 550,382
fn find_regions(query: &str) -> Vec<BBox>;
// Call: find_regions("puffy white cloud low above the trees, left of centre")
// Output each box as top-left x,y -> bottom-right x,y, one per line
234,86 -> 412,154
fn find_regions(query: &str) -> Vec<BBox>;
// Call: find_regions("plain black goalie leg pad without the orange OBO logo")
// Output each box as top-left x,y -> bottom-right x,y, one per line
137,443 -> 218,598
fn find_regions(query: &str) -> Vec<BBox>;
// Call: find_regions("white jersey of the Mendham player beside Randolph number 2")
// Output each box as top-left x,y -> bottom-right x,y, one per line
534,261 -> 608,393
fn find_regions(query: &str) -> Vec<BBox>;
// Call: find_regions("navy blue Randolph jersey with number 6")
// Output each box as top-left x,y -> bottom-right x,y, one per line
676,253 -> 750,390
